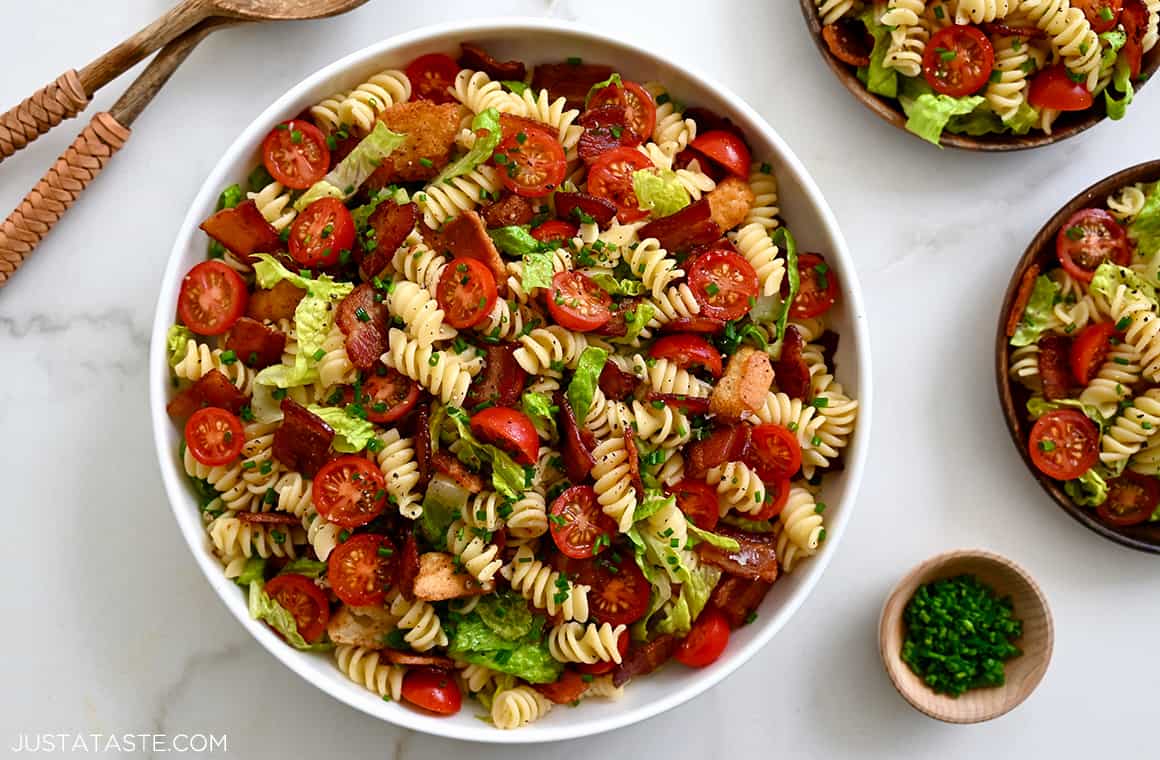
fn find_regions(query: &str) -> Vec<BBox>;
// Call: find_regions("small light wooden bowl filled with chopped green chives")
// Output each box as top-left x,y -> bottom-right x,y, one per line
878,549 -> 1054,723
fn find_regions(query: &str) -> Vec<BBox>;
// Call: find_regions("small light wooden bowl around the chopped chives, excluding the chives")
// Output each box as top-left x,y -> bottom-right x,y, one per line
878,549 -> 1056,723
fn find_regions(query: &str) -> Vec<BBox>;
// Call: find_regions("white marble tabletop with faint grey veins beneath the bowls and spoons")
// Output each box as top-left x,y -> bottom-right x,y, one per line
0,0 -> 1160,760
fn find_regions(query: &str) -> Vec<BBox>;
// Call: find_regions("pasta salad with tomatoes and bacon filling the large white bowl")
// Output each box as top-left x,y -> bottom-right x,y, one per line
168,44 -> 858,729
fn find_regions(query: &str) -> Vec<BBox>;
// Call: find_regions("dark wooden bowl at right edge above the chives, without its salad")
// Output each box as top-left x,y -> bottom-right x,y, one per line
995,161 -> 1160,553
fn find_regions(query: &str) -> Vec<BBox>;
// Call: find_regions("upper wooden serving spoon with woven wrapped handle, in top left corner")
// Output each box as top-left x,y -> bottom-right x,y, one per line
0,0 -> 367,161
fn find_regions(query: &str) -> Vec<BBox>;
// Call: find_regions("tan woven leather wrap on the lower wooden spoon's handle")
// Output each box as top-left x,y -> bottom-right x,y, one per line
0,113 -> 129,288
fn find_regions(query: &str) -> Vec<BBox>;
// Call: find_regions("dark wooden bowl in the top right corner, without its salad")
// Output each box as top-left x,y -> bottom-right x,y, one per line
799,0 -> 1160,152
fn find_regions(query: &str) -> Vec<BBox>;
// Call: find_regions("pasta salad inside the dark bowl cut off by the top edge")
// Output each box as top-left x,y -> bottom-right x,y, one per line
814,0 -> 1160,145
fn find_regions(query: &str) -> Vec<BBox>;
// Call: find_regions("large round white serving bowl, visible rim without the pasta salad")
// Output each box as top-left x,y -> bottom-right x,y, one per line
150,19 -> 871,743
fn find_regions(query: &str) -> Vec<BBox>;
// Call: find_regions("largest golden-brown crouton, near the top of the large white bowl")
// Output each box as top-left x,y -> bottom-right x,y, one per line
367,100 -> 463,190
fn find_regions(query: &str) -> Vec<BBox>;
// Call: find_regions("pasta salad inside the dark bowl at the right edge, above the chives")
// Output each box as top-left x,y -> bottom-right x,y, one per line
1007,172 -> 1160,527
